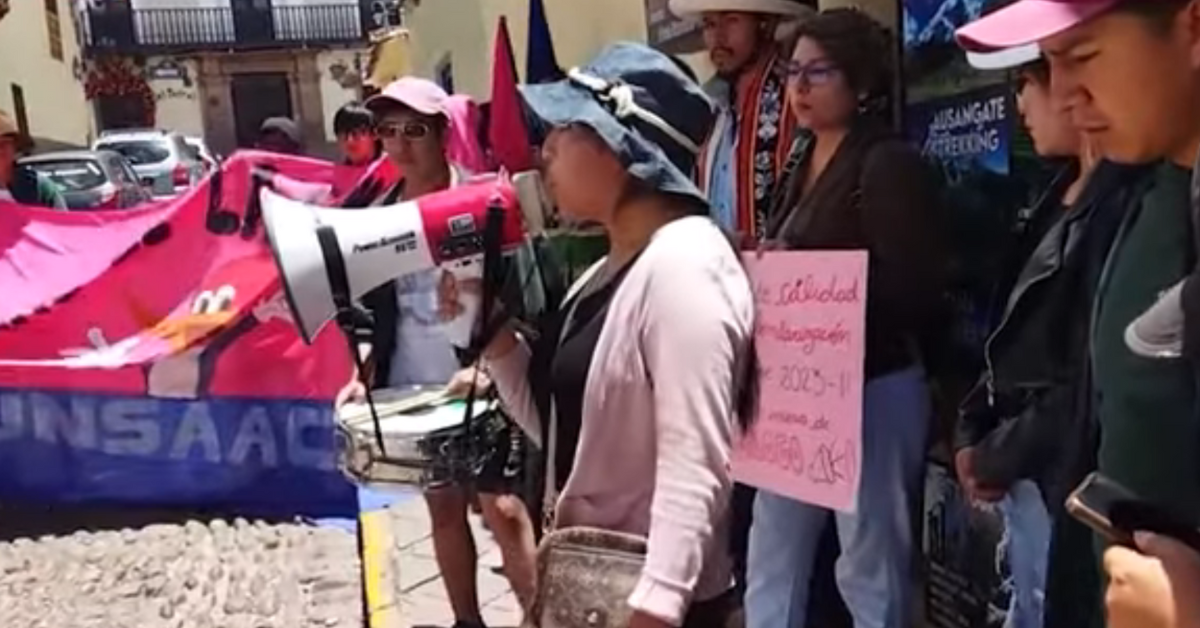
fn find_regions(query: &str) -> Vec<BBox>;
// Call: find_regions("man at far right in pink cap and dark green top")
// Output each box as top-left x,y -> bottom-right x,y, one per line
958,0 -> 1200,626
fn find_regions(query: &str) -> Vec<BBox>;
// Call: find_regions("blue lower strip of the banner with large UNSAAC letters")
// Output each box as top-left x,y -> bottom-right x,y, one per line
0,389 -> 356,516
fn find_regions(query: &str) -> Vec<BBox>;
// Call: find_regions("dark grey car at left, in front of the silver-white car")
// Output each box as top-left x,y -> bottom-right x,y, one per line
17,150 -> 151,209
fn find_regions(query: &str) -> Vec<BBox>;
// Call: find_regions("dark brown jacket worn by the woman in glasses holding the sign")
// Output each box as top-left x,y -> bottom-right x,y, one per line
767,121 -> 948,378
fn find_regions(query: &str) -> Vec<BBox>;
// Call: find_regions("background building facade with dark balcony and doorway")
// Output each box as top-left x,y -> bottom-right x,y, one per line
79,0 -> 383,152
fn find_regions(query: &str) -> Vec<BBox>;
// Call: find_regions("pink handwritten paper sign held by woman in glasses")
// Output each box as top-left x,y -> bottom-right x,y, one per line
733,251 -> 866,512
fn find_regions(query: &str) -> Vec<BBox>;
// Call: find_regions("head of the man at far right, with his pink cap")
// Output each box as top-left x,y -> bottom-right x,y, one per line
956,0 -> 1200,168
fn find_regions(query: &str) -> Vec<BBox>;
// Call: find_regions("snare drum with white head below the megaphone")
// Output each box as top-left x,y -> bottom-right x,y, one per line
337,389 -> 503,488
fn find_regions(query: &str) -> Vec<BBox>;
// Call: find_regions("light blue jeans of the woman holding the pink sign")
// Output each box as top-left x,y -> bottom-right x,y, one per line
745,367 -> 931,628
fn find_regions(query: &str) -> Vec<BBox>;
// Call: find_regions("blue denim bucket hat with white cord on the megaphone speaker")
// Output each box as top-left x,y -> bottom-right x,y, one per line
520,42 -> 714,204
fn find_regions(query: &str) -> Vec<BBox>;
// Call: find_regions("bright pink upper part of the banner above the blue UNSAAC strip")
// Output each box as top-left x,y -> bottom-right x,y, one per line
0,151 -> 396,399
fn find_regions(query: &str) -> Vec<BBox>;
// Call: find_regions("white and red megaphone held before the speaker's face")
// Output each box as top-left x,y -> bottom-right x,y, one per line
267,173 -> 544,347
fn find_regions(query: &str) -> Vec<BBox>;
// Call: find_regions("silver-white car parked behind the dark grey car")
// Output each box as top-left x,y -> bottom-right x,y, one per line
92,130 -> 204,197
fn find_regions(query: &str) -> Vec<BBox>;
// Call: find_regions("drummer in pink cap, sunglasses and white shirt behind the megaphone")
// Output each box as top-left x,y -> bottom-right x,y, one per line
328,77 -> 534,628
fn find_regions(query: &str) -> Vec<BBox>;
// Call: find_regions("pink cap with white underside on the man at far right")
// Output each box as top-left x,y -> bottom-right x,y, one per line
954,0 -> 1121,52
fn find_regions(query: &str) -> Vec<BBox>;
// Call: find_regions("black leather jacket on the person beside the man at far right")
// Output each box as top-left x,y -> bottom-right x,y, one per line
955,162 -> 1147,512
